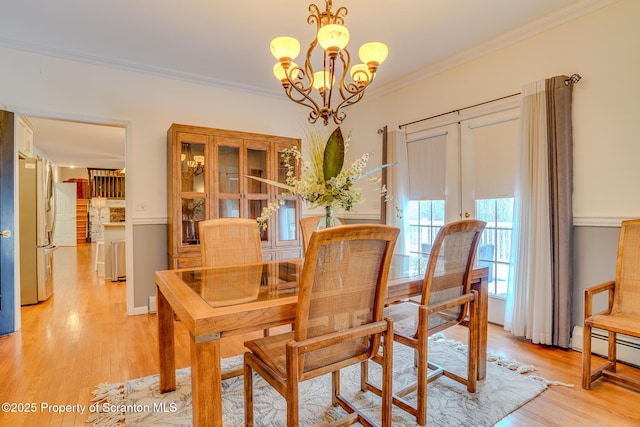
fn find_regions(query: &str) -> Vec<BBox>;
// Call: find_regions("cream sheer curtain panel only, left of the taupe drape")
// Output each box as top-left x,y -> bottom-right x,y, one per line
504,80 -> 552,344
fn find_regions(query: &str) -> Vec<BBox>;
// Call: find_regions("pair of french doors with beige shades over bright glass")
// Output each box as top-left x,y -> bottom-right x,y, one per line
406,108 -> 519,324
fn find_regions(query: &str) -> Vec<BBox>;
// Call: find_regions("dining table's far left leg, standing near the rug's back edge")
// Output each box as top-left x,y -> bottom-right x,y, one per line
156,286 -> 176,393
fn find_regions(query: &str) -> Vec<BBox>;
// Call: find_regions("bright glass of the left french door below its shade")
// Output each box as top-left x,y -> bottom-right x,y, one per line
407,200 -> 445,257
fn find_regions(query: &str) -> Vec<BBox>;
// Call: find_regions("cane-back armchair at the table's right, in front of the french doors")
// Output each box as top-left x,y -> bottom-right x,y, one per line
362,220 -> 486,425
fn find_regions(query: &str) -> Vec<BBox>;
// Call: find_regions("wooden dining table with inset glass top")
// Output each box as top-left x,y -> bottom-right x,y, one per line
155,254 -> 488,427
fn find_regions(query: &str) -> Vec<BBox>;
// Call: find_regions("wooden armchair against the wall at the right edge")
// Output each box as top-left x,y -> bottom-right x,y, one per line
582,219 -> 640,389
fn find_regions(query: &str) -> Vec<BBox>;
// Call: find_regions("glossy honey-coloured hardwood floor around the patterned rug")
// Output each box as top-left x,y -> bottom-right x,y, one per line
0,245 -> 640,426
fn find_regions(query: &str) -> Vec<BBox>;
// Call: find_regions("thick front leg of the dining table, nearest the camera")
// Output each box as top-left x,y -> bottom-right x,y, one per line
191,334 -> 222,427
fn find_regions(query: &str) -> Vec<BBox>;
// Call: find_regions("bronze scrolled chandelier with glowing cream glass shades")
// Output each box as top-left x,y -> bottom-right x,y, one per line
271,0 -> 388,125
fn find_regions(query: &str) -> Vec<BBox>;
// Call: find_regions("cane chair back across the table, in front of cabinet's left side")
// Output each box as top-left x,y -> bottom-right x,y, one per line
198,218 -> 262,267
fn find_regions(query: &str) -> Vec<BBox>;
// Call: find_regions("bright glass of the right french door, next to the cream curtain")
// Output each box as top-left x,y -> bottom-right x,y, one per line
476,197 -> 513,298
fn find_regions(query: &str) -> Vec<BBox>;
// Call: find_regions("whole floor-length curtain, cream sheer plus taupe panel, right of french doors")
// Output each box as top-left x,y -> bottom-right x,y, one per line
505,76 -> 574,348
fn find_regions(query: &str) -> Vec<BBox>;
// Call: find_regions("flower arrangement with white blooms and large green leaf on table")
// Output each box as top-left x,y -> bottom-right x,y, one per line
249,127 -> 399,230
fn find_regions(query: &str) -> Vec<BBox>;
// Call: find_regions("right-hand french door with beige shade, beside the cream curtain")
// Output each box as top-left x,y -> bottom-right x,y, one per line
460,108 -> 520,325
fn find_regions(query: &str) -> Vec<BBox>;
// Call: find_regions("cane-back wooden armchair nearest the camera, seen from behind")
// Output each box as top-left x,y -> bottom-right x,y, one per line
244,225 -> 399,427
